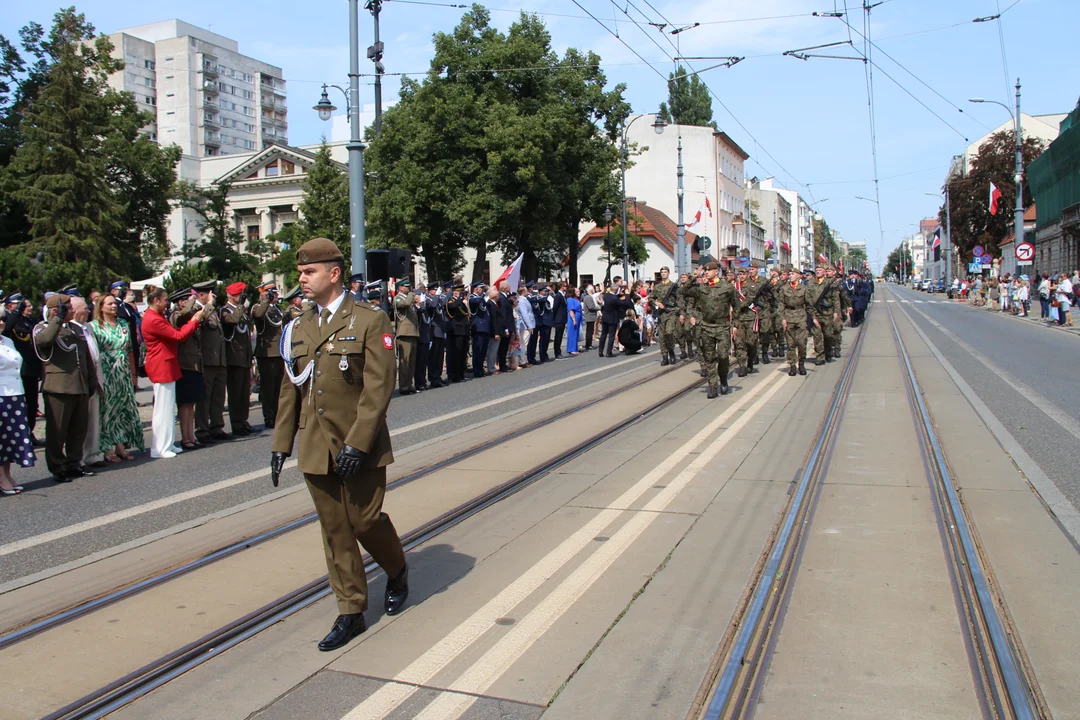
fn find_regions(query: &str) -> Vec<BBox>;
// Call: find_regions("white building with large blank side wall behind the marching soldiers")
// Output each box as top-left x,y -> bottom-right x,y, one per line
622,114 -> 747,259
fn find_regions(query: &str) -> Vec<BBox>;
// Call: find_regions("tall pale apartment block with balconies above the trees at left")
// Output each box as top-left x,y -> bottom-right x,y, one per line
109,19 -> 288,158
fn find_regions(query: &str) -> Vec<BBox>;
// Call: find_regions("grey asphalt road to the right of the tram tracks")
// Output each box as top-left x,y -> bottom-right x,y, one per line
876,285 -> 1080,508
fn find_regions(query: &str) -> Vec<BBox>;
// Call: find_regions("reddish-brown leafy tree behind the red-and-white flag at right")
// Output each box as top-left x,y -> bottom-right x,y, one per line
937,131 -> 1045,260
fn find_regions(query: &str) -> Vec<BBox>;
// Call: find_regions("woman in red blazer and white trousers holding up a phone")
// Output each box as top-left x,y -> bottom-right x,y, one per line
143,287 -> 214,459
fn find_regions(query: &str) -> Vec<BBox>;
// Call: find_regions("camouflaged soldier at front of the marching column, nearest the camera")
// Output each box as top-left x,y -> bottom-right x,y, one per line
681,260 -> 738,398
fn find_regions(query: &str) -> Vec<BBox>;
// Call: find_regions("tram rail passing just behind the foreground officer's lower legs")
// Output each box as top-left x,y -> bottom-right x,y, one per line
43,373 -> 704,720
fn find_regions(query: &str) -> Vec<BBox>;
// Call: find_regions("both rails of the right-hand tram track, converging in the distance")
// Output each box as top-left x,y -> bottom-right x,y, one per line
688,291 -> 1051,720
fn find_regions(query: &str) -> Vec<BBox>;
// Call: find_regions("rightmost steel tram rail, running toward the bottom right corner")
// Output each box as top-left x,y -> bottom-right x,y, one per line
889,302 -> 1039,720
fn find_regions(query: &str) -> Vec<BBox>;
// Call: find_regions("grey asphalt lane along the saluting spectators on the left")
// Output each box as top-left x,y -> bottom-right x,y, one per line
0,348 -> 658,584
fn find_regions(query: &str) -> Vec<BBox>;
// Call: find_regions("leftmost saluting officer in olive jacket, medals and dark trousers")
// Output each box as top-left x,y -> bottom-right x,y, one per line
33,293 -> 100,483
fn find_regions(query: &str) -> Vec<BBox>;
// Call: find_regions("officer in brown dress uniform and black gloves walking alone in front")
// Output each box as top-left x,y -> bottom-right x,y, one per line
270,237 -> 408,651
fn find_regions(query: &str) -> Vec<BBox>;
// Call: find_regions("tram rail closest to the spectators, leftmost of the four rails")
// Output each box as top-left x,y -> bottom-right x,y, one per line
0,366 -> 678,651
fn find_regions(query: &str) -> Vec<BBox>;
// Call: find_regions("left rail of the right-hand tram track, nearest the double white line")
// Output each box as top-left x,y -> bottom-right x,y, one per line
703,310 -> 866,720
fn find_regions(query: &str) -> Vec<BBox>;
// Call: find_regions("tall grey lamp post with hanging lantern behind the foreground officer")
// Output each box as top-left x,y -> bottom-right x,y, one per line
313,0 -> 367,275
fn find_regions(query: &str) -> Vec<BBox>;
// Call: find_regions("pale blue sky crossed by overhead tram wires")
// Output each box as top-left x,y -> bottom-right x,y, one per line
0,0 -> 1080,266
